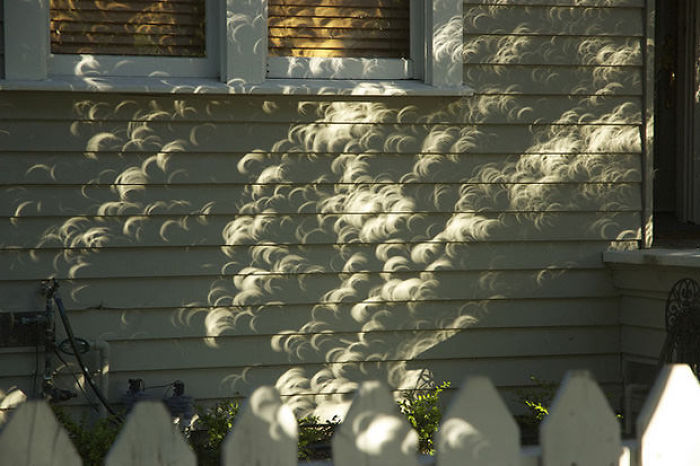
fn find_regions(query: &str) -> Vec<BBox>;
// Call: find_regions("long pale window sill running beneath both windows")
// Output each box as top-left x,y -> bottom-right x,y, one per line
0,76 -> 474,96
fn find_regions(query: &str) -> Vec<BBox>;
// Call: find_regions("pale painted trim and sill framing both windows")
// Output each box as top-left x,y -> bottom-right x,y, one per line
0,0 -> 473,96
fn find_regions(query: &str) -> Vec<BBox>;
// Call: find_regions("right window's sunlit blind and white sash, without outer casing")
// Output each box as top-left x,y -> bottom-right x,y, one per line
267,0 -> 422,79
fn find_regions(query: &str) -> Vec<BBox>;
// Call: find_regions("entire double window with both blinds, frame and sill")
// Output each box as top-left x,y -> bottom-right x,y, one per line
2,0 -> 469,95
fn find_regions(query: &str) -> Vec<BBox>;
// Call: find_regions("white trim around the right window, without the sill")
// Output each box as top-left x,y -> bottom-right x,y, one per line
221,0 -> 464,88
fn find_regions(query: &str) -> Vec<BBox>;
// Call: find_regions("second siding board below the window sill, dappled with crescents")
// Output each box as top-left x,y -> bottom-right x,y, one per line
0,121 -> 641,153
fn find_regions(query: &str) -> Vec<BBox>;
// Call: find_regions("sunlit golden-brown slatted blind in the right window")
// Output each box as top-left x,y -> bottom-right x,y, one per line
268,0 -> 411,58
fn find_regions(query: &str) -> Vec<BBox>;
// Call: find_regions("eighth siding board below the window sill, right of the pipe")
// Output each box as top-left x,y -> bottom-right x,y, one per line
38,297 -> 617,341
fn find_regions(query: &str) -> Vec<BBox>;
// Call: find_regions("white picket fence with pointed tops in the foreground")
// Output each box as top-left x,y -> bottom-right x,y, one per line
0,365 -> 700,466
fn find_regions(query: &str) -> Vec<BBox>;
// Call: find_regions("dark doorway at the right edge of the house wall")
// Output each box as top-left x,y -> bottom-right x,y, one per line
654,0 -> 700,247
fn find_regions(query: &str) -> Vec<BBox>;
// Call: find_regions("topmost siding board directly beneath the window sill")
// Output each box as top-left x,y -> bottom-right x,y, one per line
0,93 -> 642,124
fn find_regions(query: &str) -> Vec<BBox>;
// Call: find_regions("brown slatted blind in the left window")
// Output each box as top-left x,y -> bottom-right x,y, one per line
49,0 -> 206,57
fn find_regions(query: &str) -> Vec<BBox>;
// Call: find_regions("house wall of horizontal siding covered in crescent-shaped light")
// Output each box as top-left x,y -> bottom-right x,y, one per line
0,0 -> 645,412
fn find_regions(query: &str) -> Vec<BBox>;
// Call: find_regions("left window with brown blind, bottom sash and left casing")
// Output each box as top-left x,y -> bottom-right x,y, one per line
4,0 -> 219,79
